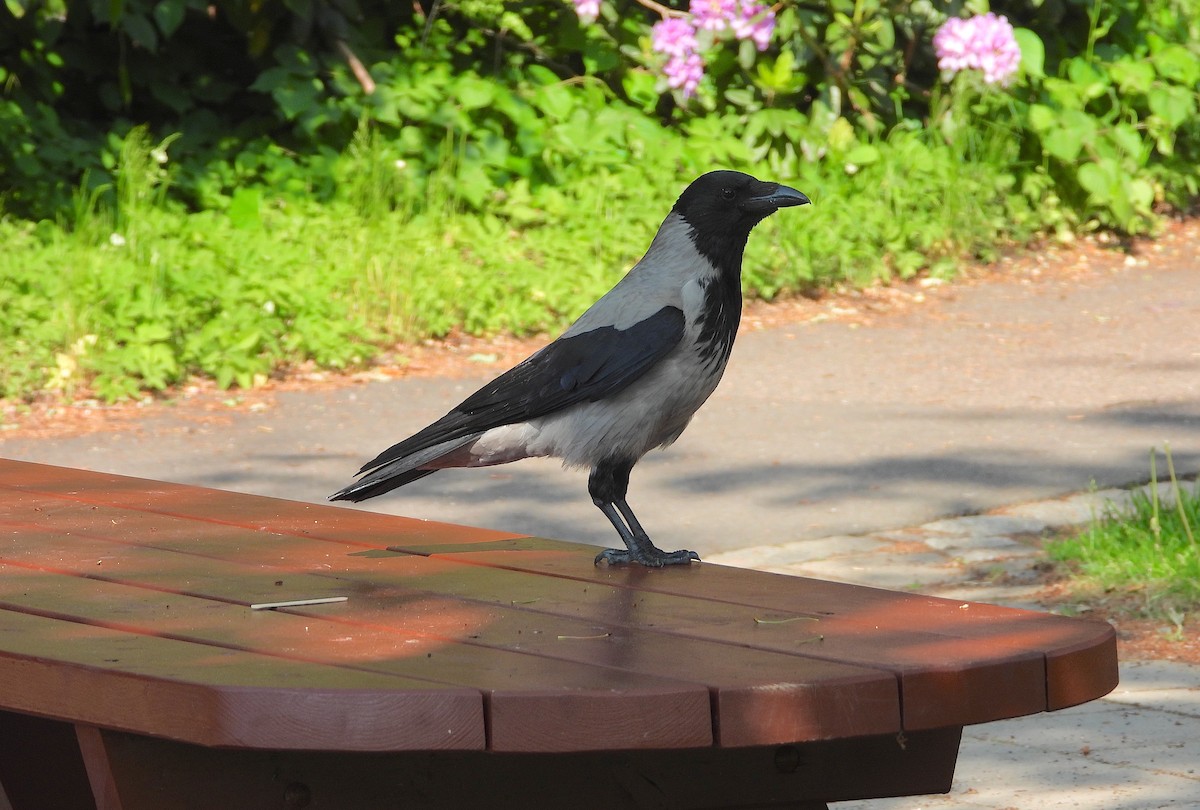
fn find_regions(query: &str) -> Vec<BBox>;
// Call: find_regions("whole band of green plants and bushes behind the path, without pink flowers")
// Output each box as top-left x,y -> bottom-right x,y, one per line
0,0 -> 1200,398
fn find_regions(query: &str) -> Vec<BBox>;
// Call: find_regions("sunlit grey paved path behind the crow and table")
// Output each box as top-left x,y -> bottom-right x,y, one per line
0,226 -> 1200,810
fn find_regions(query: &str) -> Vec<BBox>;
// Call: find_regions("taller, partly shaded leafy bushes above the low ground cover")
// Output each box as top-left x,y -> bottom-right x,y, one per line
0,0 -> 1200,230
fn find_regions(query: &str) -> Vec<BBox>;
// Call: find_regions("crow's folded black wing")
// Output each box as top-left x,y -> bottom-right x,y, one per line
359,306 -> 684,474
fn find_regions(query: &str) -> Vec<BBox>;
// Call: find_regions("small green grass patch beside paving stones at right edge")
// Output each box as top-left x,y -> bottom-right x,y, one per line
1046,448 -> 1200,624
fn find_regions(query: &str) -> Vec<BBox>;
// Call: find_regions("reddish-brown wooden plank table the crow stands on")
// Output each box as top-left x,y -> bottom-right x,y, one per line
0,461 -> 1117,810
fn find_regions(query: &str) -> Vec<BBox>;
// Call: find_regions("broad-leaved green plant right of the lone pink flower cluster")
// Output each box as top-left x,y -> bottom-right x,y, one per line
992,0 -> 1200,233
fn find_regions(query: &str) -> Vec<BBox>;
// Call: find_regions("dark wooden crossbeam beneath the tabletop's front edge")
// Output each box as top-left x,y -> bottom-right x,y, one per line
75,728 -> 961,810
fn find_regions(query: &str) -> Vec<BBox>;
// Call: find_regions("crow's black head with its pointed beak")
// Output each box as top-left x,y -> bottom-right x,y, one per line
672,172 -> 809,272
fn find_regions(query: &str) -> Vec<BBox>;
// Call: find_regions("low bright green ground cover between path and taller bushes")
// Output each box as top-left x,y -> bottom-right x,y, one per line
0,112 -> 1032,400
